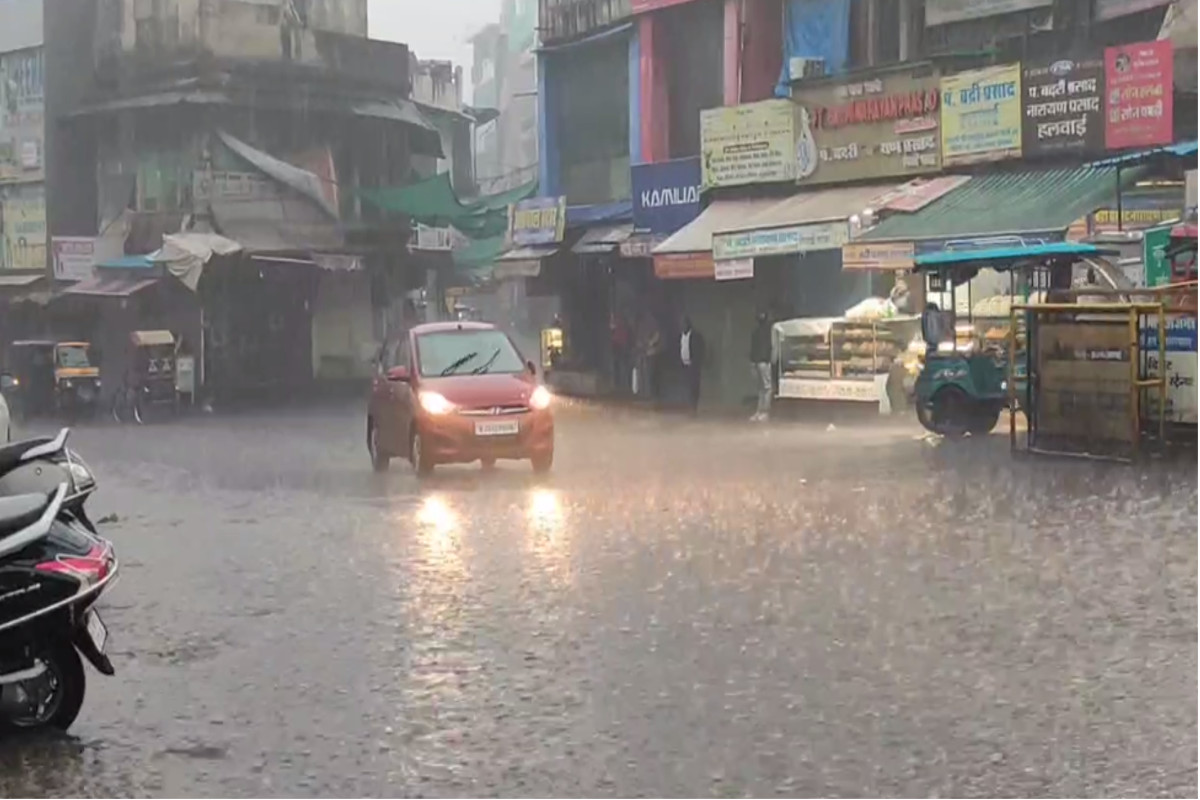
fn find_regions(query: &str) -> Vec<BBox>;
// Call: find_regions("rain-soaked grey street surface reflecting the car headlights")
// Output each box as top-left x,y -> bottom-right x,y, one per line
0,405 -> 1196,796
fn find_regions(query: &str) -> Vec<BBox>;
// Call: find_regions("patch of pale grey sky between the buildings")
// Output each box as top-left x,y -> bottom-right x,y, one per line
367,0 -> 500,96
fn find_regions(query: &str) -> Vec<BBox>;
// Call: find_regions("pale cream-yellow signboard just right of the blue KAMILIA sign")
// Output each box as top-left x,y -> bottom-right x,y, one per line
700,100 -> 811,187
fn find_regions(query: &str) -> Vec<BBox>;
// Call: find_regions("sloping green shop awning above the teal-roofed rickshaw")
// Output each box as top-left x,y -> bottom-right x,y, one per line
859,167 -> 1140,241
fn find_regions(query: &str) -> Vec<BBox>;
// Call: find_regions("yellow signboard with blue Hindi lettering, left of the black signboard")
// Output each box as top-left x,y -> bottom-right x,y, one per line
942,64 -> 1021,167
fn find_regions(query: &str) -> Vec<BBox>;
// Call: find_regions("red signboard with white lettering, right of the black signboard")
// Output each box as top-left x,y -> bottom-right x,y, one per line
1104,41 -> 1175,150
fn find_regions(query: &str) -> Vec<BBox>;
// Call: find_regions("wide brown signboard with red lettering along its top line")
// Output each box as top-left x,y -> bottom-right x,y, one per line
793,73 -> 941,185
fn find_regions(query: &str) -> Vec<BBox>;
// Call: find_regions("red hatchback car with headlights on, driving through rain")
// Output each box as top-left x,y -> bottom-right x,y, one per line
367,321 -> 554,475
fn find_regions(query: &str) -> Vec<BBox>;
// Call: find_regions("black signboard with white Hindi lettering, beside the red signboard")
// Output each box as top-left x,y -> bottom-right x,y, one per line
1021,58 -> 1104,157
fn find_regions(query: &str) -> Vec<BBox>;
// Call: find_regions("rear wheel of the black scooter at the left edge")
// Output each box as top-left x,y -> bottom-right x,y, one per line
0,642 -> 86,730
